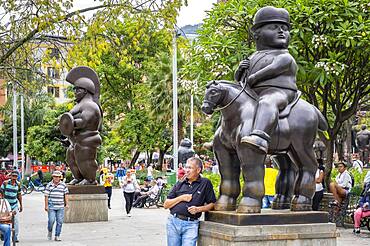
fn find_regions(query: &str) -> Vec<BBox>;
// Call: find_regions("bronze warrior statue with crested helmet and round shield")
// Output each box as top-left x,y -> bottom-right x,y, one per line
59,66 -> 103,185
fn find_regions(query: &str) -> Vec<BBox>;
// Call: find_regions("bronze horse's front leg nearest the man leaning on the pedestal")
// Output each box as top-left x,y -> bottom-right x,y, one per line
213,136 -> 240,211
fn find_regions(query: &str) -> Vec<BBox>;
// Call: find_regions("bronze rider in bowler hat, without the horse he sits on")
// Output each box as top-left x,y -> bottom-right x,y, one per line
235,6 -> 297,153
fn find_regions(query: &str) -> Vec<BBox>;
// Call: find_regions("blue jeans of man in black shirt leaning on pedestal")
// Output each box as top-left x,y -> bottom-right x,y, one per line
167,214 -> 199,246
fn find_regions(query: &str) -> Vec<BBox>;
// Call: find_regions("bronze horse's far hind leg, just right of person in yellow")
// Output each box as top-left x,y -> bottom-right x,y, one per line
271,154 -> 296,209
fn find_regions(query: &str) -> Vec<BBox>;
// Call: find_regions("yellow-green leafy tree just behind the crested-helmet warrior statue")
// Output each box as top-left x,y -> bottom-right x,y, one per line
69,1 -> 181,164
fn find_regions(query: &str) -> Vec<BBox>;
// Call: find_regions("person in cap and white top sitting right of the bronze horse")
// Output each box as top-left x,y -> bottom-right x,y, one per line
329,162 -> 354,207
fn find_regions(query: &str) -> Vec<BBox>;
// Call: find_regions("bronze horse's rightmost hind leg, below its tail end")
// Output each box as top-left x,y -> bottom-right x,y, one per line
289,146 -> 318,211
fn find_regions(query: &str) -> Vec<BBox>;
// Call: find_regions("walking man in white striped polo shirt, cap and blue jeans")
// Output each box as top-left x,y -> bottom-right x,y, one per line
45,171 -> 68,241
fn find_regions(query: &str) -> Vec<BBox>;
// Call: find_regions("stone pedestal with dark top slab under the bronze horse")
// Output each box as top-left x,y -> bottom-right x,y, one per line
198,210 -> 339,246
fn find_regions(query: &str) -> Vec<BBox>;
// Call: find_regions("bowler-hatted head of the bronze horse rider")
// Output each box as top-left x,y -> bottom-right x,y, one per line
252,6 -> 290,50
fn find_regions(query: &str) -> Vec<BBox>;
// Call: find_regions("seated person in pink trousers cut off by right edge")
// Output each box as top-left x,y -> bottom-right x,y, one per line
353,183 -> 370,235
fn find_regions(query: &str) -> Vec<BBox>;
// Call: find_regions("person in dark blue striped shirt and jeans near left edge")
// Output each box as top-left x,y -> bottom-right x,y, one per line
1,170 -> 23,242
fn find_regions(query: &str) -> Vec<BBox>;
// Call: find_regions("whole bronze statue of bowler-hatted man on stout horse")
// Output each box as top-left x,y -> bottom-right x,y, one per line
202,7 -> 328,213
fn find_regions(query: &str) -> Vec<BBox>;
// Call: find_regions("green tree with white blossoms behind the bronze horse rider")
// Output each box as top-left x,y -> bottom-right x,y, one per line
187,0 -> 370,181
